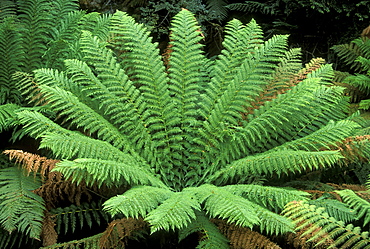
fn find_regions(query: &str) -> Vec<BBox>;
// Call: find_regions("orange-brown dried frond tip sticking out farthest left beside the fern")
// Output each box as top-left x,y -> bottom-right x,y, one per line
3,150 -> 59,178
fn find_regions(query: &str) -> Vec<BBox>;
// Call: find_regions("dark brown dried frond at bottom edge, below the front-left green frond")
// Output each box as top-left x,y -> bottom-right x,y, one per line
99,218 -> 147,249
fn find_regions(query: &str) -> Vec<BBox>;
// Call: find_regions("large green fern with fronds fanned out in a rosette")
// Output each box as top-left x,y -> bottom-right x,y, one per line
17,9 -> 364,248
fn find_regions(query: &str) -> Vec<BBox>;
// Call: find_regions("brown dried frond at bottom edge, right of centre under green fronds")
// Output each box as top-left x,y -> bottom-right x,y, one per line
212,219 -> 281,249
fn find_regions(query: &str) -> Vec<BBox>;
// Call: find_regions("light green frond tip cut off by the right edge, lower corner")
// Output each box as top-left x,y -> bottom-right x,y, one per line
335,189 -> 370,226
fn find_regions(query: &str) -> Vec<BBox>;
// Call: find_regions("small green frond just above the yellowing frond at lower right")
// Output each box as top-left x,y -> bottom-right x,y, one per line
308,197 -> 357,223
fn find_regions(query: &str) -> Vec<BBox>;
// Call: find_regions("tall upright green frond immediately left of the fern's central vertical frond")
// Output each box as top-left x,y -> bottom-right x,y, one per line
110,11 -> 177,165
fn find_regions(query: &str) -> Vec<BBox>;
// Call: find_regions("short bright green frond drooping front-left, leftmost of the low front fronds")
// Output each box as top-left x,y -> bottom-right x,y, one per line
103,186 -> 172,218
